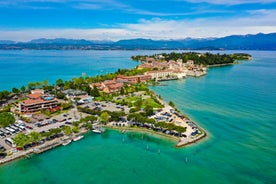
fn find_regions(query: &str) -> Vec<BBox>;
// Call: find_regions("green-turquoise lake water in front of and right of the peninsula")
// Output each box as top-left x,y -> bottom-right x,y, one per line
0,51 -> 276,184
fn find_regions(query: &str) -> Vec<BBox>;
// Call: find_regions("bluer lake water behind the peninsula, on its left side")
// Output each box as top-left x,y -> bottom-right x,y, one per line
0,50 -> 137,90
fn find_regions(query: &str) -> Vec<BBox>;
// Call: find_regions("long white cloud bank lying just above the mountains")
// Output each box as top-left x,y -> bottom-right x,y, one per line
0,10 -> 276,41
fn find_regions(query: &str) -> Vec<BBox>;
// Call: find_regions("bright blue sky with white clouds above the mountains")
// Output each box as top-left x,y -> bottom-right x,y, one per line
0,0 -> 276,41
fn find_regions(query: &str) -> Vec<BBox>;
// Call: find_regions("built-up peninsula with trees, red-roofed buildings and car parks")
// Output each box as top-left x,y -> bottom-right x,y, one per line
0,52 -> 251,163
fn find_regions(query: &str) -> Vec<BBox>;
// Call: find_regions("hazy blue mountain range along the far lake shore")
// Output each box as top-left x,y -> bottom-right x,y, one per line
0,33 -> 276,50
